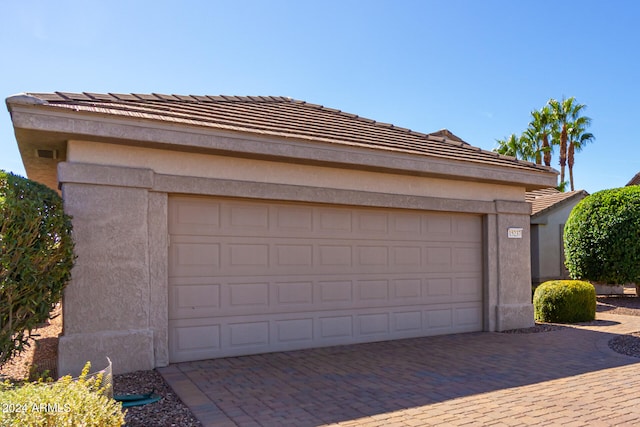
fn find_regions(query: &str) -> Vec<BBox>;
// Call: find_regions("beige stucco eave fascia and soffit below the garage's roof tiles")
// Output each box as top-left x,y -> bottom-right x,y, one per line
7,99 -> 557,191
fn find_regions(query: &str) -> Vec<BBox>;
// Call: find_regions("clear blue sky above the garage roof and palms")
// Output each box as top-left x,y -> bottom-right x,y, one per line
0,0 -> 640,192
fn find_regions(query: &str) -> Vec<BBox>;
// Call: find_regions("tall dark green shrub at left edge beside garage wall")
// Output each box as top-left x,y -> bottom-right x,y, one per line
0,171 -> 74,365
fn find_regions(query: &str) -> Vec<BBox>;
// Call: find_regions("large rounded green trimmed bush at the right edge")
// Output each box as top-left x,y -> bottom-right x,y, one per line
564,186 -> 640,285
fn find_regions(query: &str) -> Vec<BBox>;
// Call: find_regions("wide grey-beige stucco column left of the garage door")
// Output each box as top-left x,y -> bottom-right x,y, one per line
58,163 -> 162,375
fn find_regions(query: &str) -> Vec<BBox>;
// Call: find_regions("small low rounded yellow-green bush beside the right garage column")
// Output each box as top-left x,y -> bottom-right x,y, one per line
533,280 -> 596,323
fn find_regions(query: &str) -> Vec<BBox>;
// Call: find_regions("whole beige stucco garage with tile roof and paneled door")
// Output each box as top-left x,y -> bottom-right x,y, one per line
7,93 -> 556,374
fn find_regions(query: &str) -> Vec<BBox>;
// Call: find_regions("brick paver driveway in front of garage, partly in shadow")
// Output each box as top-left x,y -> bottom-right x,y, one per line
159,313 -> 640,426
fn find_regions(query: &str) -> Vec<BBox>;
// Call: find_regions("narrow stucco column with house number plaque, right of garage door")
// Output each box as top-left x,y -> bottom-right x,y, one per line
494,200 -> 534,331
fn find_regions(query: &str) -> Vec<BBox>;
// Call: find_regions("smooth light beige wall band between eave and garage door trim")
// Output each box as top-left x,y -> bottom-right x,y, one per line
67,141 -> 524,201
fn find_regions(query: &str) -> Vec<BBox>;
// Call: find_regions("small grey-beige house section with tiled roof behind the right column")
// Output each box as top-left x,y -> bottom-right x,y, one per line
526,188 -> 588,286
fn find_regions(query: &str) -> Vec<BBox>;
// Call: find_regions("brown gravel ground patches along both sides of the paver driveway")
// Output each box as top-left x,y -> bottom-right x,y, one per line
0,295 -> 640,427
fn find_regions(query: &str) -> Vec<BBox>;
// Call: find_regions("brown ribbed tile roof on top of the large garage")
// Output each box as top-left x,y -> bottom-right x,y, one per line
16,92 -> 554,172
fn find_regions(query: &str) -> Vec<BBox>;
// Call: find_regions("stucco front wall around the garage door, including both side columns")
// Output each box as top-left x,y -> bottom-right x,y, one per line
58,141 -> 533,374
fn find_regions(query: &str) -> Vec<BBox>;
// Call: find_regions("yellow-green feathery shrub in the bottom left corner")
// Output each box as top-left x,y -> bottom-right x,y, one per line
0,363 -> 124,427
